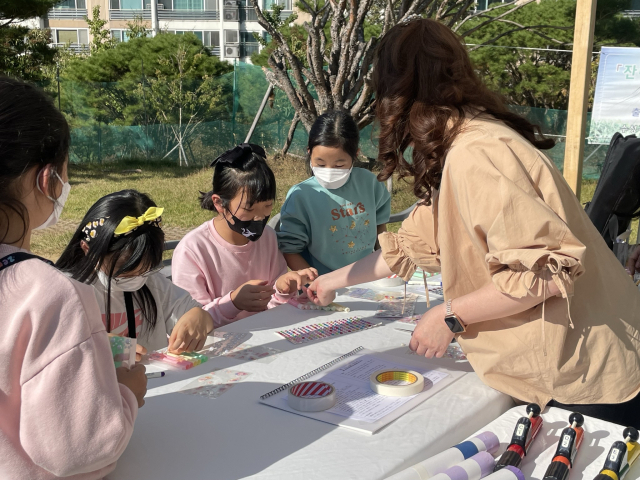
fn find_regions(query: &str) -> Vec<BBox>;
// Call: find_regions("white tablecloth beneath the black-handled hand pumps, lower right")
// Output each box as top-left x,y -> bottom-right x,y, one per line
464,406 -> 640,480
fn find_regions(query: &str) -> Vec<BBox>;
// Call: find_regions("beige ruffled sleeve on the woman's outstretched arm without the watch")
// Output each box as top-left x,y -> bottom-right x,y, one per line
378,205 -> 440,281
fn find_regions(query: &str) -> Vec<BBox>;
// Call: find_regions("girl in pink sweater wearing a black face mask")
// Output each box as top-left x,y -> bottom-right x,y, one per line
172,144 -> 318,327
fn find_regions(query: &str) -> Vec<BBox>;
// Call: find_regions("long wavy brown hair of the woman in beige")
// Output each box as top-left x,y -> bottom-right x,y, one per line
373,19 -> 554,205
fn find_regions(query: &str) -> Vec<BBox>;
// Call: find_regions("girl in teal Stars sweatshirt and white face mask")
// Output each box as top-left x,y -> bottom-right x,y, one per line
278,111 -> 391,274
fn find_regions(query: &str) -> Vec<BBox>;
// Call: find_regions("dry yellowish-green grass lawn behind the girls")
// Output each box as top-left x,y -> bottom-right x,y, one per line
31,157 -> 616,261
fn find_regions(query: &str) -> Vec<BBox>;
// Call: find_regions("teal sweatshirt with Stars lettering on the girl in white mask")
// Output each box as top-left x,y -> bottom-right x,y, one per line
278,168 -> 391,275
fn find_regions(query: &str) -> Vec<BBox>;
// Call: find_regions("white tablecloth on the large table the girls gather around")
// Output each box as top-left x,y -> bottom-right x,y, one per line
107,288 -> 513,480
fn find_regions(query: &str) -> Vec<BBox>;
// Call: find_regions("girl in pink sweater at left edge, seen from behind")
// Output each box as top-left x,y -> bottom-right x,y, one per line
0,77 -> 147,480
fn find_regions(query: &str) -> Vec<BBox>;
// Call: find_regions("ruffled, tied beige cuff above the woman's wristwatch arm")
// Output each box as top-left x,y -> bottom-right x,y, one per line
486,250 -> 584,298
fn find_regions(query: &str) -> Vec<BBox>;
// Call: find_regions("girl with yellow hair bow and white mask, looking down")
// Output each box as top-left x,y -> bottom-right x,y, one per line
57,190 -> 213,354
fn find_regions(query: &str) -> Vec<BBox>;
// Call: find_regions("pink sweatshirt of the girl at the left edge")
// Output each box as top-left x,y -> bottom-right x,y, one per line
0,245 -> 138,480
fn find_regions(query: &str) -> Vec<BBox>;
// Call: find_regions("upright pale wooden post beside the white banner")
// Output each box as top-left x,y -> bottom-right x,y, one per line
564,0 -> 597,199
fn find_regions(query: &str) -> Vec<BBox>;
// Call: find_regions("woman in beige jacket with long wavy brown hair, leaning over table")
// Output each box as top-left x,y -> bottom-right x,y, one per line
309,19 -> 640,428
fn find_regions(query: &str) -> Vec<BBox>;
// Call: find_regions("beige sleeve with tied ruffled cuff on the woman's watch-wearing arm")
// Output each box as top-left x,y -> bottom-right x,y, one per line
440,138 -> 586,298
